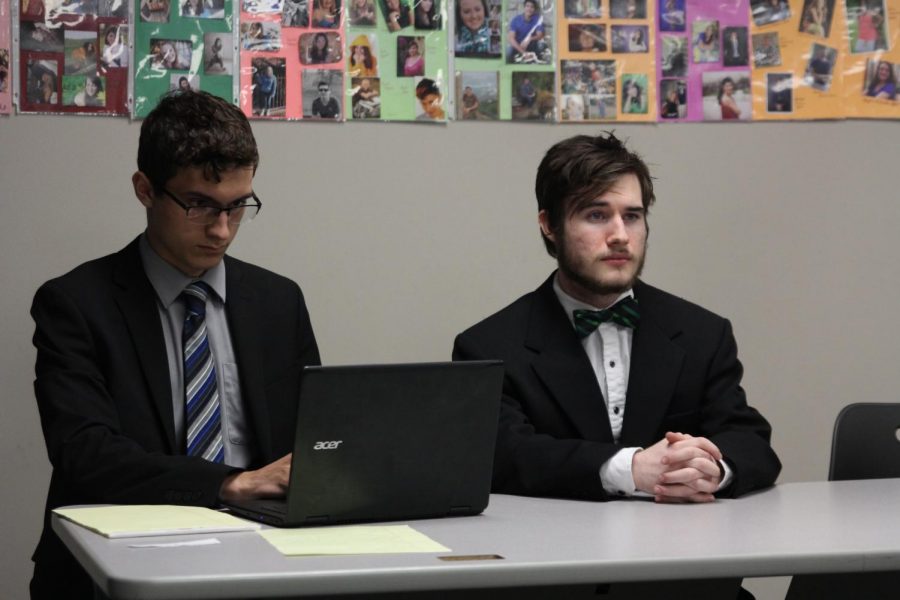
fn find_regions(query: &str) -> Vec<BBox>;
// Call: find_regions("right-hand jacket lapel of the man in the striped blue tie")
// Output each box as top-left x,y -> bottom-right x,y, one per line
225,256 -> 272,462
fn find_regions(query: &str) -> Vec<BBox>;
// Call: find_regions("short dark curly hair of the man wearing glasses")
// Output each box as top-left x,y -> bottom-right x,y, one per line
138,90 -> 259,194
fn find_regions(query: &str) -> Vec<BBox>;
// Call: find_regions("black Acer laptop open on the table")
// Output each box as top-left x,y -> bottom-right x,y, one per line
226,361 -> 503,527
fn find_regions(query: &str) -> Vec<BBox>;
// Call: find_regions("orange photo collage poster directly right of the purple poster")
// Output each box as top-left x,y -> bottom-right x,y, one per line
750,0 -> 847,121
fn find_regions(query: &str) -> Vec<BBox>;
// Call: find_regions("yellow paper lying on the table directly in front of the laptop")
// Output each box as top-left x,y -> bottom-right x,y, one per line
259,525 -> 450,556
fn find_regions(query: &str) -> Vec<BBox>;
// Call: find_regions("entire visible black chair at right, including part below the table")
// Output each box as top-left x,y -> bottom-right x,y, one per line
785,402 -> 900,600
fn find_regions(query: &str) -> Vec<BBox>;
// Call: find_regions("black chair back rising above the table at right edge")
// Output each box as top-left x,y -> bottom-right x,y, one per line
828,402 -> 900,481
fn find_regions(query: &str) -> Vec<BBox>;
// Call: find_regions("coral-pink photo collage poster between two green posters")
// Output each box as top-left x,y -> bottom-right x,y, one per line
235,0 -> 345,122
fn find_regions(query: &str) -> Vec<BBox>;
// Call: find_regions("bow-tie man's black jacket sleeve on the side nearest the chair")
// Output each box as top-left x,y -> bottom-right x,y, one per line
702,320 -> 781,497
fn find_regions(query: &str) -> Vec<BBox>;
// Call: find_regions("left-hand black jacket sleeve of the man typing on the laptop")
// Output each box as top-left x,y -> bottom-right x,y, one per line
31,282 -> 234,506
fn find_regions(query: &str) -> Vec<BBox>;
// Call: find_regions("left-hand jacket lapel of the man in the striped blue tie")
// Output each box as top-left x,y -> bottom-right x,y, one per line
113,240 -> 183,453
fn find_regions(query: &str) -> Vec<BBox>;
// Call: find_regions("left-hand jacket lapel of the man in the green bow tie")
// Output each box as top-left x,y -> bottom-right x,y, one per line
525,275 -> 612,442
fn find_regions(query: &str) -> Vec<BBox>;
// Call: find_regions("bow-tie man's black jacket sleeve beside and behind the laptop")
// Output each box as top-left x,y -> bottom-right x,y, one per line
453,333 -> 621,500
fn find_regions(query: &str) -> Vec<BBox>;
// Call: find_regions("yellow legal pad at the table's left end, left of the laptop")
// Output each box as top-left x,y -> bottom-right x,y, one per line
53,504 -> 259,538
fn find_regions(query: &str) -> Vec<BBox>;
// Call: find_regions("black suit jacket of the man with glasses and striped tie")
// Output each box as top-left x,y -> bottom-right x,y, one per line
31,240 -> 319,598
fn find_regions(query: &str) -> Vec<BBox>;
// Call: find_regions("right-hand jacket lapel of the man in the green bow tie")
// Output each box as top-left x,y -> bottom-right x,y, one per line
619,282 -> 684,446
